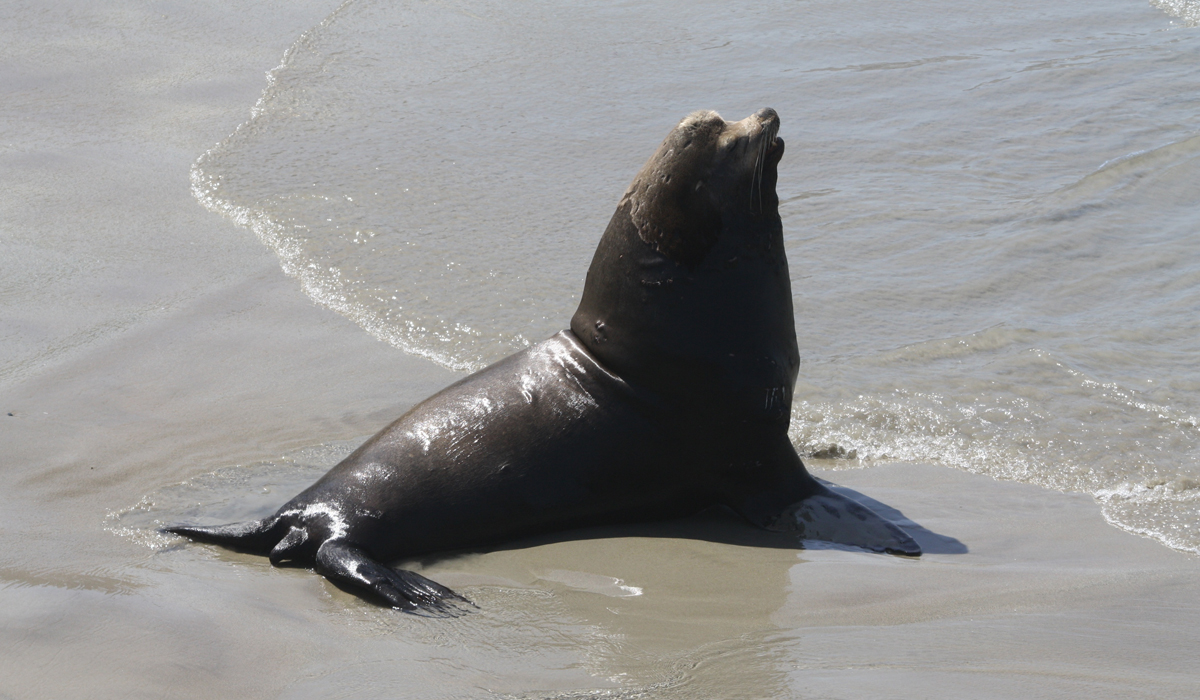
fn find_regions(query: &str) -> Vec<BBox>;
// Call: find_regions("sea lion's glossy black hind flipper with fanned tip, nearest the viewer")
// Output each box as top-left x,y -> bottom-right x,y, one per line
317,539 -> 475,617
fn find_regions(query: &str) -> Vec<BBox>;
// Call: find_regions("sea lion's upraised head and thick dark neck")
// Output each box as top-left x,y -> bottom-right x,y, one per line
571,108 -> 799,426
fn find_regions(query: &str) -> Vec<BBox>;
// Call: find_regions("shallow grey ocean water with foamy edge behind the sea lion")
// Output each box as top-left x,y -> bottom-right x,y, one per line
192,0 -> 1200,554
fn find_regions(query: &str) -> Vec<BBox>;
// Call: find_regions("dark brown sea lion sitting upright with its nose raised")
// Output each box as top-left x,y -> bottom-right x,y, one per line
167,109 -> 920,614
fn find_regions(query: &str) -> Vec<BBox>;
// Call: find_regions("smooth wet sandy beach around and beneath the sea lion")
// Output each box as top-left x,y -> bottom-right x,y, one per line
0,2 -> 1200,700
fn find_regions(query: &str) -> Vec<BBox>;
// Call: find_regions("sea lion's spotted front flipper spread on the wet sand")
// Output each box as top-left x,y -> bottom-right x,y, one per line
767,486 -> 920,557
